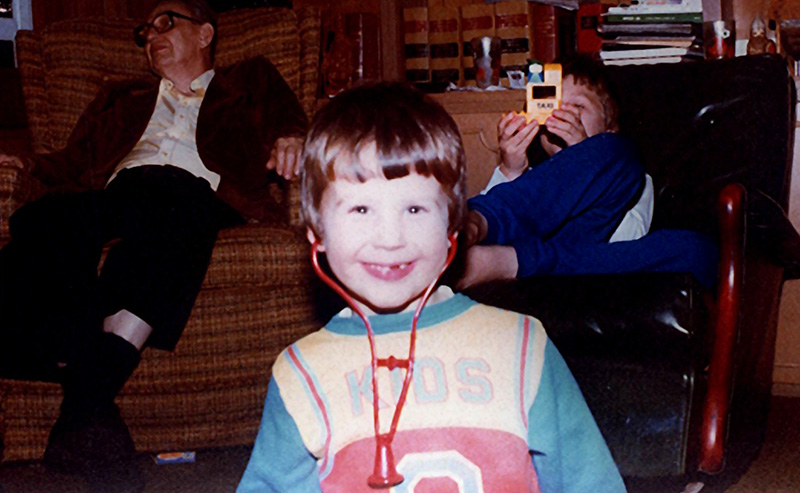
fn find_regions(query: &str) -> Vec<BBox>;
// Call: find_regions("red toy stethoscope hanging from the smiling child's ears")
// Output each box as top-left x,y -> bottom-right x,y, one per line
311,233 -> 458,489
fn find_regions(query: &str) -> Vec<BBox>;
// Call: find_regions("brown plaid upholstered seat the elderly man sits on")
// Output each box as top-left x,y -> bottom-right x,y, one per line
0,9 -> 320,460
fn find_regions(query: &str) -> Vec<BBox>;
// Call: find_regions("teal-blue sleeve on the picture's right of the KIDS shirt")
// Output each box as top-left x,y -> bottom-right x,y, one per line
528,340 -> 625,493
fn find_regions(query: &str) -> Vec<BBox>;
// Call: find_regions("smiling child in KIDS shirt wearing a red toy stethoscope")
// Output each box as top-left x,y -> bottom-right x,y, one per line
238,83 -> 625,493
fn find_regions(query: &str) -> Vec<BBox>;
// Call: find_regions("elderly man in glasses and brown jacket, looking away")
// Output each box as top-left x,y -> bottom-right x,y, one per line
0,0 -> 307,484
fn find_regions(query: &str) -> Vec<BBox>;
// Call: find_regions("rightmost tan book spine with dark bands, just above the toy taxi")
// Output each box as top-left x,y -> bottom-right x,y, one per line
494,2 -> 533,86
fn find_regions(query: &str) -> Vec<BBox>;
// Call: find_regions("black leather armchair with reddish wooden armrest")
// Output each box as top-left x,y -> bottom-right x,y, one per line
467,55 -> 800,484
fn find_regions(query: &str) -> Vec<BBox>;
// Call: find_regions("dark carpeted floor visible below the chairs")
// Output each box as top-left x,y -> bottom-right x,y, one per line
0,397 -> 800,493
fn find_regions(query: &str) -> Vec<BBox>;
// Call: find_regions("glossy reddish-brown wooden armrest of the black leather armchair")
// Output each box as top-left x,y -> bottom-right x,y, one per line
698,183 -> 746,474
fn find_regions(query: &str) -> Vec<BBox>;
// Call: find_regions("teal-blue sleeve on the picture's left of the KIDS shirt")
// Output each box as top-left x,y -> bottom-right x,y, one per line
236,378 -> 322,493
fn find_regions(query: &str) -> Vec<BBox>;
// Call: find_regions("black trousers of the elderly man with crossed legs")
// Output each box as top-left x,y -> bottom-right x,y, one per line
0,166 -> 240,379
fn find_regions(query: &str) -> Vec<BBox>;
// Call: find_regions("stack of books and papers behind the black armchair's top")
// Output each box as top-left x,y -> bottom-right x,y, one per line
597,0 -> 703,65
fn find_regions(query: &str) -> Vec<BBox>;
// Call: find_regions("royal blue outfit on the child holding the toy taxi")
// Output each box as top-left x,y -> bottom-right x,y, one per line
469,133 -> 717,286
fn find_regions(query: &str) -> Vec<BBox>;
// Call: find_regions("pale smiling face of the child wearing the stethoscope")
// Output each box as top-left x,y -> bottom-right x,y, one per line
309,145 -> 450,312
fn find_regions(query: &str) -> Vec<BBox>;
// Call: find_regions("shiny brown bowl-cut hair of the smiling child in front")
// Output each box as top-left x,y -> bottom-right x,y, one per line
300,82 -> 466,238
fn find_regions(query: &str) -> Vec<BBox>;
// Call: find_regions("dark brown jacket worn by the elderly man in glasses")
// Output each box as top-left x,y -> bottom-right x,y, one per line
26,58 -> 308,221
